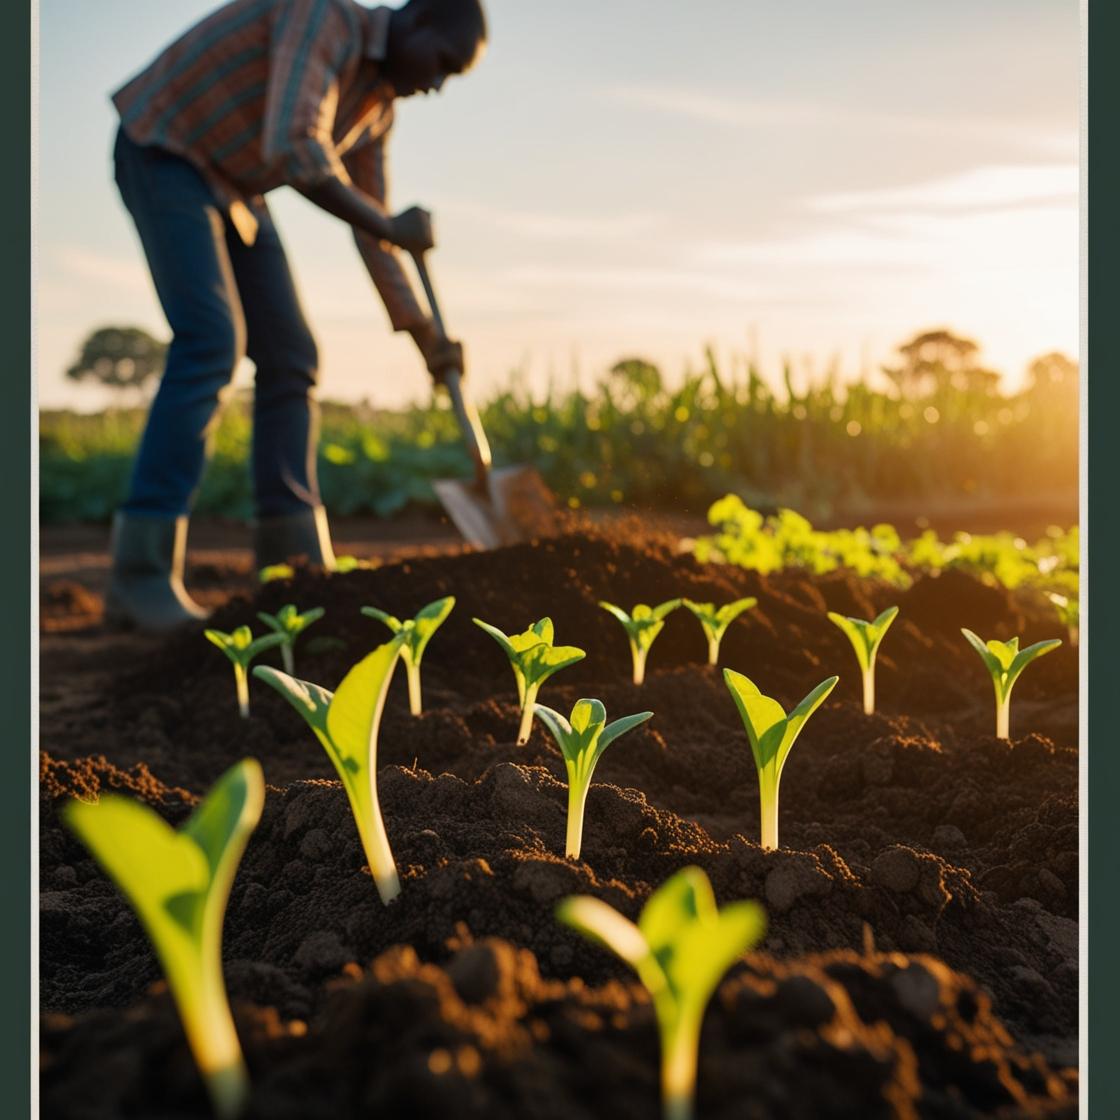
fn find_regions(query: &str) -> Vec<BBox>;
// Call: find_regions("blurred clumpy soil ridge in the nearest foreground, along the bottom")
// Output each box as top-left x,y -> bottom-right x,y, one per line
44,939 -> 1076,1120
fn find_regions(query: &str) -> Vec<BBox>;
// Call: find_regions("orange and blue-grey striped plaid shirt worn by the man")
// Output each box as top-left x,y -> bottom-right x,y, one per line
113,0 -> 427,330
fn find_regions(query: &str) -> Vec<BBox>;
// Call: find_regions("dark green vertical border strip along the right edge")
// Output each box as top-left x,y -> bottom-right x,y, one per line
1081,0 -> 1120,1117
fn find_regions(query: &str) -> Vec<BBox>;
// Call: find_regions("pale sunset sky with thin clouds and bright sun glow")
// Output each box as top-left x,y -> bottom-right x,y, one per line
35,0 -> 1080,410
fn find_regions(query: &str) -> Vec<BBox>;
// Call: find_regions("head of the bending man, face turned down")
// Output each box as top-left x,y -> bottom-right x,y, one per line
383,0 -> 486,97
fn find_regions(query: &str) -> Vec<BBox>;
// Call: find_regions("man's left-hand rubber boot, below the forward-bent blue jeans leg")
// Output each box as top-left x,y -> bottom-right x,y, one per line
105,512 -> 209,633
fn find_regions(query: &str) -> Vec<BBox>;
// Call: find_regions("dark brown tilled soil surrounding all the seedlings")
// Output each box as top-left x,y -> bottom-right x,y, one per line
40,532 -> 1077,1120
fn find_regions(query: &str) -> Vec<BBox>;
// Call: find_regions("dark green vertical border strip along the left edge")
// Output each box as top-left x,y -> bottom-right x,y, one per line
0,0 -> 32,1117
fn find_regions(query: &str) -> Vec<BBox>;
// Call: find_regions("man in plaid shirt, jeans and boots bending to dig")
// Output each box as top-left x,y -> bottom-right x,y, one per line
105,0 -> 486,631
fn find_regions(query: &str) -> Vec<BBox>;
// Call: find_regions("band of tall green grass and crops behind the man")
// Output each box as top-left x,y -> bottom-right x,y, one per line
39,355 -> 1077,522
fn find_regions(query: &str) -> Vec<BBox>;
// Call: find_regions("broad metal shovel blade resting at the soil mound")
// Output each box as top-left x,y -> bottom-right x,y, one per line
432,467 -> 557,549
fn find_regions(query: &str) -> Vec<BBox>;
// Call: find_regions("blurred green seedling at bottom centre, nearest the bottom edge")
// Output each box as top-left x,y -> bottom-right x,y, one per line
557,867 -> 766,1120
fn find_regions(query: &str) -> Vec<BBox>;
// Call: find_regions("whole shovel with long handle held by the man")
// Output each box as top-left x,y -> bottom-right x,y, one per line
412,253 -> 557,549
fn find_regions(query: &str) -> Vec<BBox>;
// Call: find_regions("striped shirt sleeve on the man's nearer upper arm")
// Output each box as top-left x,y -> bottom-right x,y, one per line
261,0 -> 352,187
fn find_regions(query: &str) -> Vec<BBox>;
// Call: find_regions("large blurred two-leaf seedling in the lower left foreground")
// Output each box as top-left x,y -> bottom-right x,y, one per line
62,758 -> 264,1120
